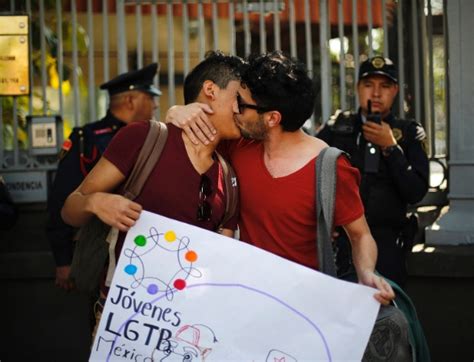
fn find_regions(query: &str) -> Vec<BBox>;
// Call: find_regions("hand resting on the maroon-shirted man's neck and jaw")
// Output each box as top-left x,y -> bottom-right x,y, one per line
165,103 -> 217,145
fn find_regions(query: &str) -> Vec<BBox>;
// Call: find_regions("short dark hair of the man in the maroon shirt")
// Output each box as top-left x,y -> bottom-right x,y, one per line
184,51 -> 245,104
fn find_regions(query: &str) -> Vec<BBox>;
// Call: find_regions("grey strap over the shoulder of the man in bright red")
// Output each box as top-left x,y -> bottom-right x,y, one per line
316,147 -> 343,277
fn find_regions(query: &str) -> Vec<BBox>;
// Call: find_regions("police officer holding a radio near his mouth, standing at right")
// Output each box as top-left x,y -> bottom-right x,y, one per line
317,56 -> 429,285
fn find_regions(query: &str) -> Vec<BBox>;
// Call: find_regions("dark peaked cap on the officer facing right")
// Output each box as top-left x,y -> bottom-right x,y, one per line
100,63 -> 161,96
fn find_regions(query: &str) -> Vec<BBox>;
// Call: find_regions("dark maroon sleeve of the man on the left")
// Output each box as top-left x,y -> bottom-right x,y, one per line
104,121 -> 150,177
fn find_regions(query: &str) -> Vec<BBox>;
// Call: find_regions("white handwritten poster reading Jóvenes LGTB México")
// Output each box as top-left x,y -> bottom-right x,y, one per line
90,212 -> 379,362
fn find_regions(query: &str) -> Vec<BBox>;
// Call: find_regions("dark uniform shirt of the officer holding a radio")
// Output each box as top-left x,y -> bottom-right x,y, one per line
317,112 -> 429,226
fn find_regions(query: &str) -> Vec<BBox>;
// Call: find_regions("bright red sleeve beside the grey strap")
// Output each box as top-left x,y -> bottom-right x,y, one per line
334,156 -> 364,226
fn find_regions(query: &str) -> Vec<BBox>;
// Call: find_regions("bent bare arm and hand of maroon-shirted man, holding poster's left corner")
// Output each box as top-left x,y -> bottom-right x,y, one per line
61,157 -> 142,231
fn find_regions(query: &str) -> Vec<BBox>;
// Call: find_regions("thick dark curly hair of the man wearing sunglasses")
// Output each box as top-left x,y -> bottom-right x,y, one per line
242,51 -> 315,132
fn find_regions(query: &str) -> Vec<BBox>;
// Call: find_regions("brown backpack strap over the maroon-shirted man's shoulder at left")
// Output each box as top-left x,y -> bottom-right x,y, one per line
105,119 -> 168,286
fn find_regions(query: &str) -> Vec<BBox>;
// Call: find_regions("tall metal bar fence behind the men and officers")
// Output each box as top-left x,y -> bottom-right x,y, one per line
0,0 -> 447,177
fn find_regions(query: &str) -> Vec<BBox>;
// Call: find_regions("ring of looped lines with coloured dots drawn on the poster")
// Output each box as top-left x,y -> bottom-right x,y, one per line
124,227 -> 202,301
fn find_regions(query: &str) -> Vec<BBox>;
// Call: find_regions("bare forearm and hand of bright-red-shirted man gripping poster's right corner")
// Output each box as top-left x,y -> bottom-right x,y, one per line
344,216 -> 395,305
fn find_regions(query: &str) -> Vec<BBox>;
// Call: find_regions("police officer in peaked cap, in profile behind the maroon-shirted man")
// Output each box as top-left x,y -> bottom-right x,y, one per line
46,63 -> 161,290
